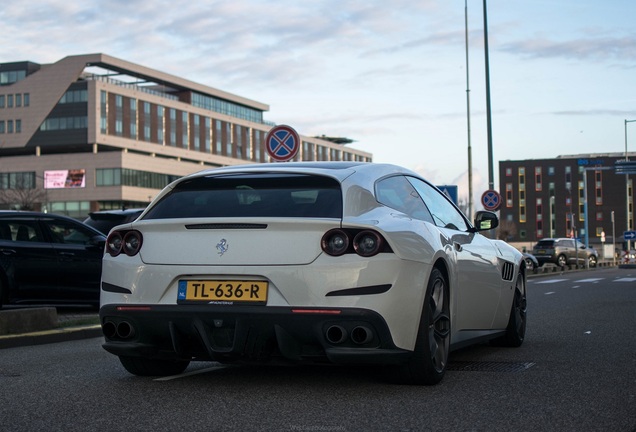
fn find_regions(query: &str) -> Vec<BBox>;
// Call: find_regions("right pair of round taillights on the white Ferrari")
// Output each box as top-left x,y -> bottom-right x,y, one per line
320,228 -> 391,257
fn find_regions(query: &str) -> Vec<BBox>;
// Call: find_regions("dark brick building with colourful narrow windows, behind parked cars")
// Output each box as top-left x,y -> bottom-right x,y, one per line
499,153 -> 636,250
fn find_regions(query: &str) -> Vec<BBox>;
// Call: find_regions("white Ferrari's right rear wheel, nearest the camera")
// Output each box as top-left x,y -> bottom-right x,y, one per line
393,268 -> 451,385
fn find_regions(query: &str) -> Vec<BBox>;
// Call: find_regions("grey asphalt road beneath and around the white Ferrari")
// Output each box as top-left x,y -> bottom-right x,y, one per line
0,269 -> 636,432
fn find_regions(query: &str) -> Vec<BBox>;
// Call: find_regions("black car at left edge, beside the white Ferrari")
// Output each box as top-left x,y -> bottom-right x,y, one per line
0,211 -> 106,307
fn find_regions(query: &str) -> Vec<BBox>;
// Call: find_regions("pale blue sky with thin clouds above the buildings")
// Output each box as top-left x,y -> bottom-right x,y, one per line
0,0 -> 636,208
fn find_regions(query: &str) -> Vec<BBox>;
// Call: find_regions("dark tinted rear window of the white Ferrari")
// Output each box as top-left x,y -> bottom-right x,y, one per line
144,173 -> 342,219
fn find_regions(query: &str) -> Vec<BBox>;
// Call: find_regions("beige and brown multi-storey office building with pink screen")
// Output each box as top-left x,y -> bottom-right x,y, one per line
0,54 -> 372,218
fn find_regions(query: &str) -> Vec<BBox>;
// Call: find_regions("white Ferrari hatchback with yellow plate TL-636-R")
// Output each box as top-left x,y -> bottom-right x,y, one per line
100,162 -> 526,384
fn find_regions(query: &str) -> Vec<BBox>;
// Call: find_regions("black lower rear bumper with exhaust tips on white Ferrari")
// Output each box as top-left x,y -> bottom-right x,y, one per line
100,304 -> 411,364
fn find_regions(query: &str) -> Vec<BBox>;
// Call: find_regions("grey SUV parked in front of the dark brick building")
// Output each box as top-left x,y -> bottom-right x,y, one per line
532,238 -> 598,267
